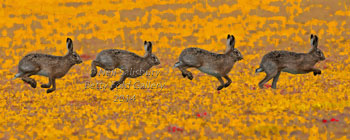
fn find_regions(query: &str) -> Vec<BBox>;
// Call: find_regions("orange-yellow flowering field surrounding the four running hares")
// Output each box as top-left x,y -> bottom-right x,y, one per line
0,0 -> 350,139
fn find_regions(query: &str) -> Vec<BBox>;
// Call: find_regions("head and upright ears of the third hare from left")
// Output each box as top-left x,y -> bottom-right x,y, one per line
225,34 -> 243,61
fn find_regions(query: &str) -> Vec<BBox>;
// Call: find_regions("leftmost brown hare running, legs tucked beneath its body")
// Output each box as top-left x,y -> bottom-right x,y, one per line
14,38 -> 83,93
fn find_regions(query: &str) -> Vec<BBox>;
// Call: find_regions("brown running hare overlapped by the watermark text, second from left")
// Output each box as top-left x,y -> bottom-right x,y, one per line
91,41 -> 160,90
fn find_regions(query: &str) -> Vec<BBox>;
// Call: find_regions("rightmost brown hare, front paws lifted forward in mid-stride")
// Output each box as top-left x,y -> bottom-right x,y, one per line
255,34 -> 326,89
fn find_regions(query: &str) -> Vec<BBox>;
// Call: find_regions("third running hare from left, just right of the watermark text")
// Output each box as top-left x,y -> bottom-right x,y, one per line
174,34 -> 243,90
